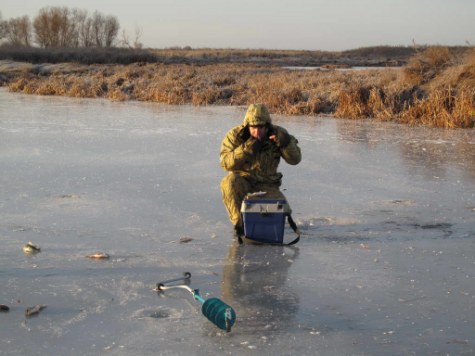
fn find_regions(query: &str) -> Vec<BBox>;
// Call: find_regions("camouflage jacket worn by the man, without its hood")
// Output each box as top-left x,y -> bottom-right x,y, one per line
220,125 -> 302,186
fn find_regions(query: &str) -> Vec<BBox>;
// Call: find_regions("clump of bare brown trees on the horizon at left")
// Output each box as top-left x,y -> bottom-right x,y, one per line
0,7 -> 125,48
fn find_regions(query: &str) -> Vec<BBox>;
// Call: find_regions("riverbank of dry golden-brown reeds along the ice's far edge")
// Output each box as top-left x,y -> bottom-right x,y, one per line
0,47 -> 475,128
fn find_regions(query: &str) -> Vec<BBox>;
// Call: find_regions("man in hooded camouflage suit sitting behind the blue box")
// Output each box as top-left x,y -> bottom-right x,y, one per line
220,104 -> 302,236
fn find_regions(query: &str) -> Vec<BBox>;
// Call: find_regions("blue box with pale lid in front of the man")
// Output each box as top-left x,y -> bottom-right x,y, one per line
241,198 -> 290,244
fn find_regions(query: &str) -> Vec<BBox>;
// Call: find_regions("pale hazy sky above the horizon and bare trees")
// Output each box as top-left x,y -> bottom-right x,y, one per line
0,0 -> 475,51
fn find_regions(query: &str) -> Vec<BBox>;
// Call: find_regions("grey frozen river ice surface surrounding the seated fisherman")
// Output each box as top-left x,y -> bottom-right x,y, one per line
0,90 -> 475,355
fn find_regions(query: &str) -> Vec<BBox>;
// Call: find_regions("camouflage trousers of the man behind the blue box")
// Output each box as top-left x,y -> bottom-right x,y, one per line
221,172 -> 285,226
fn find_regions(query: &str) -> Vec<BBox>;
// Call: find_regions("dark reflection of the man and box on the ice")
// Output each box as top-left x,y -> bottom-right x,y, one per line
223,243 -> 299,335
